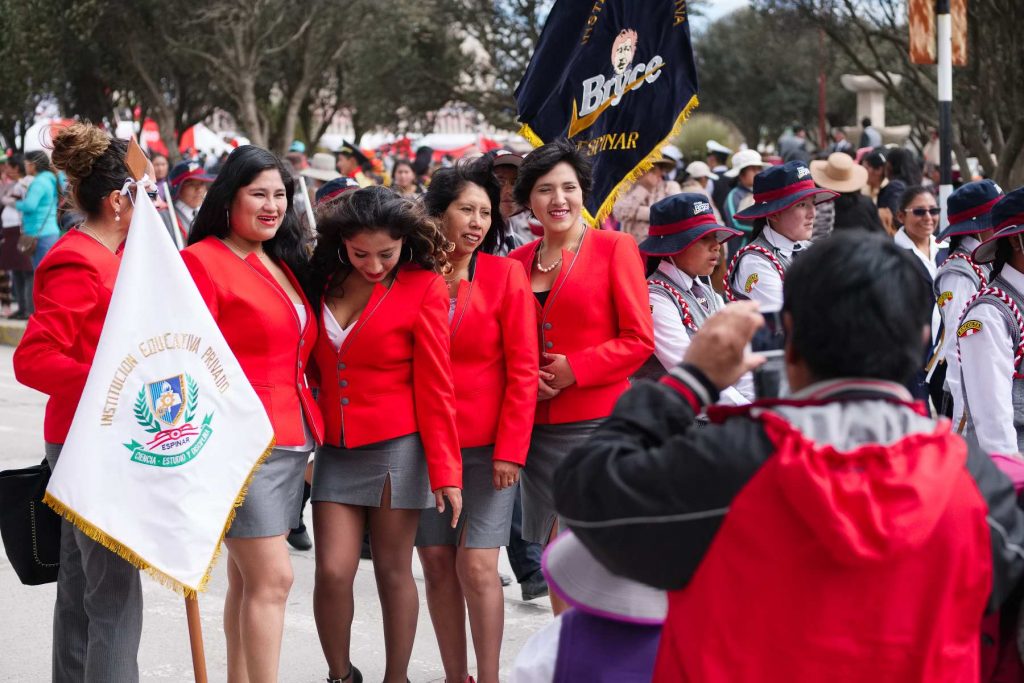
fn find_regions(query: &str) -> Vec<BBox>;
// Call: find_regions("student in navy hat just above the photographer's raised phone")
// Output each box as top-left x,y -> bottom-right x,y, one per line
725,161 -> 839,308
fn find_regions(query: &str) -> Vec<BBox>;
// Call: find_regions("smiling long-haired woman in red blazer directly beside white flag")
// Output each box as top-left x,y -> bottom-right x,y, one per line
181,145 -> 324,680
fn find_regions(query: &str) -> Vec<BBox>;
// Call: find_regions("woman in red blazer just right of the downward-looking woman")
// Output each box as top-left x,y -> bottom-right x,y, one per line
416,160 -> 539,683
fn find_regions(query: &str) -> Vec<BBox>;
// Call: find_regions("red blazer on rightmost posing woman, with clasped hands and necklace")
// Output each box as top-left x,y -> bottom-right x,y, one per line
509,230 -> 654,424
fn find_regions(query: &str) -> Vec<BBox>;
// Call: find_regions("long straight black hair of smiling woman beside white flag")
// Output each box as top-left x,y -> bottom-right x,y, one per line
188,144 -> 309,280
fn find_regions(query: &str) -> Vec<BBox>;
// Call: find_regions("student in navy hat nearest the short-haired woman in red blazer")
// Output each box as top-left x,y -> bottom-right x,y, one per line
634,193 -> 752,405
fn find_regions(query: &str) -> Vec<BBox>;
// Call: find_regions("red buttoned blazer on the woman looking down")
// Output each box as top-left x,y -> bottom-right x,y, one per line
313,266 -> 462,490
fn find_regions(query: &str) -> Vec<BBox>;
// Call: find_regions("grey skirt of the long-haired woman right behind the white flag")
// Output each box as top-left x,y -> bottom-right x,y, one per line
227,449 -> 309,539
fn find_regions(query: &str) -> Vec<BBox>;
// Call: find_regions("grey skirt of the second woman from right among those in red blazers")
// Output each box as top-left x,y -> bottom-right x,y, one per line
416,445 -> 516,548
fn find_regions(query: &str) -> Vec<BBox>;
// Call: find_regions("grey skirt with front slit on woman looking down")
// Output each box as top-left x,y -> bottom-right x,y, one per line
309,433 -> 434,510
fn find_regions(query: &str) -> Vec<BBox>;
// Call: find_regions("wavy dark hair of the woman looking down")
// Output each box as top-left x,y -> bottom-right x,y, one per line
308,185 -> 452,301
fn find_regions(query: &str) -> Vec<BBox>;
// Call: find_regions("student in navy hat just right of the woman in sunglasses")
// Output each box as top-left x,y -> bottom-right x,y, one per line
933,180 -> 1004,425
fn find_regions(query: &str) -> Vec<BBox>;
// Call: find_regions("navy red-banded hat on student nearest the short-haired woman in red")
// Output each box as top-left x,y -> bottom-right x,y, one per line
640,193 -> 742,256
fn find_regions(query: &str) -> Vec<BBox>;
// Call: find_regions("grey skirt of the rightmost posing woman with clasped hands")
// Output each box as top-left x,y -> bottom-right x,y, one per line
520,420 -> 603,544
